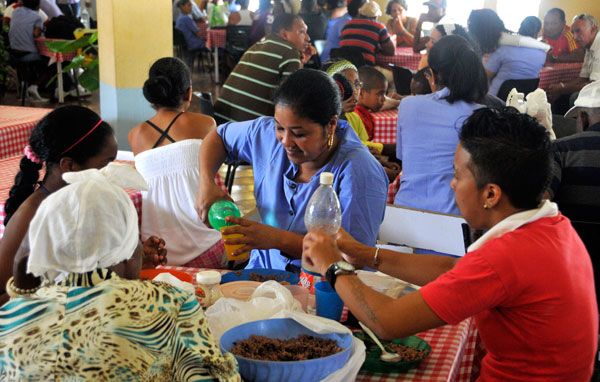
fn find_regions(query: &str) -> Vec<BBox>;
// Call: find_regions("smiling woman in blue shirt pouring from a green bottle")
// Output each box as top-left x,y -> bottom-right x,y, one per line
196,69 -> 388,272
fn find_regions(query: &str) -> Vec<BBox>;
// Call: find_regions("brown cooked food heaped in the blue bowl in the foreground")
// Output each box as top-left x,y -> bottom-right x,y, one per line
231,334 -> 343,362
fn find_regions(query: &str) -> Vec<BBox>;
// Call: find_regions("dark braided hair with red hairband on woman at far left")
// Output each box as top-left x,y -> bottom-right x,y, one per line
4,106 -> 114,226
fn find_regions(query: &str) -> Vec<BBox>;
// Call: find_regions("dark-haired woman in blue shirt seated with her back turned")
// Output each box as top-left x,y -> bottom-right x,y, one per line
394,35 -> 487,215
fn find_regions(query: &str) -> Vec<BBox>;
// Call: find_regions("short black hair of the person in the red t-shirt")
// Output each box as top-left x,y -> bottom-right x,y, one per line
459,107 -> 552,209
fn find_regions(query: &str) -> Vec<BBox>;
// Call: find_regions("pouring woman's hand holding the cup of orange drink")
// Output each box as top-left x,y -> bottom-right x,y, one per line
222,216 -> 280,256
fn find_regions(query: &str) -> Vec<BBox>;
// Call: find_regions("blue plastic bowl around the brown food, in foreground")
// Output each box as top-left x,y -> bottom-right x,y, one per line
221,318 -> 352,382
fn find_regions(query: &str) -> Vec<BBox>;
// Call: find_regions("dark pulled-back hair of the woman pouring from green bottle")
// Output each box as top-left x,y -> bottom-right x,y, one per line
273,69 -> 342,128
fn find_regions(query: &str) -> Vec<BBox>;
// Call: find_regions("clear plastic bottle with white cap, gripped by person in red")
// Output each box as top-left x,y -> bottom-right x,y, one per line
302,172 -> 342,276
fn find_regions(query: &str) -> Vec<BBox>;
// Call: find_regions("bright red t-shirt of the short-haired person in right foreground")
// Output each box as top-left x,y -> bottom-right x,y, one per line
421,214 -> 598,382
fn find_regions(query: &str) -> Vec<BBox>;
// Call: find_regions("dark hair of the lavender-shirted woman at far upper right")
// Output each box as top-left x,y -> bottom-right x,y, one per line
467,9 -> 507,54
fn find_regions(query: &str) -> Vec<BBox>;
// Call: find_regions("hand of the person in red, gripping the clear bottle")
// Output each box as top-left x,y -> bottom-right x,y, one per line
302,231 -> 342,275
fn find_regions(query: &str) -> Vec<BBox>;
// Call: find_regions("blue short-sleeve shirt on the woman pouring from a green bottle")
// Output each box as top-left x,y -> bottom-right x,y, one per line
217,117 -> 388,269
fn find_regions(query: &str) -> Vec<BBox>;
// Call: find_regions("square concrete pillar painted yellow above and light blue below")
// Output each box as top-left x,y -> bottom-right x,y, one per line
97,0 -> 173,150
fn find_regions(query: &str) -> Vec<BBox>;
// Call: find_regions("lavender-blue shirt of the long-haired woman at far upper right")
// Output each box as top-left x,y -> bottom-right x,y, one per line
485,45 -> 546,95
